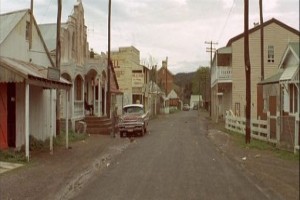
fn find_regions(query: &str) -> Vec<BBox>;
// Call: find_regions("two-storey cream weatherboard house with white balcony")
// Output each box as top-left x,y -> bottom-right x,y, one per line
211,18 -> 299,120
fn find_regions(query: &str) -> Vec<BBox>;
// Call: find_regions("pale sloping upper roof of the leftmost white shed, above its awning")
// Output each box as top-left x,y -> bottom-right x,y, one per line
0,9 -> 28,44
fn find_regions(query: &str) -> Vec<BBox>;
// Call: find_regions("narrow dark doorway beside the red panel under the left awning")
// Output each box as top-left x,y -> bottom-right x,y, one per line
7,83 -> 16,147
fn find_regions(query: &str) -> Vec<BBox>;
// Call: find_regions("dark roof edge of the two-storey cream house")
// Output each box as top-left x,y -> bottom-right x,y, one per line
226,18 -> 300,47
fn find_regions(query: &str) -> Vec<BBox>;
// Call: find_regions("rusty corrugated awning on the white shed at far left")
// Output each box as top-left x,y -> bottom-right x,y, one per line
0,57 -> 72,89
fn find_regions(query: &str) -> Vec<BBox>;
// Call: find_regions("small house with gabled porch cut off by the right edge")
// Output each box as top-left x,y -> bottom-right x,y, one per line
258,42 -> 300,150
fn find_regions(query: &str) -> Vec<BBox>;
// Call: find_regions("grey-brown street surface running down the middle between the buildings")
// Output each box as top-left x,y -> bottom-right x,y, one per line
73,111 -> 279,200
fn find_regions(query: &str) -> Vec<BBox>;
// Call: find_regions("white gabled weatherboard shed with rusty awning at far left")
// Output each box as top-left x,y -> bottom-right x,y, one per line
0,10 -> 72,160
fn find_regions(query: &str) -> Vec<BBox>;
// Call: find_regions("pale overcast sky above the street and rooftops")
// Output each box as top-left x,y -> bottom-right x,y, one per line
0,0 -> 299,74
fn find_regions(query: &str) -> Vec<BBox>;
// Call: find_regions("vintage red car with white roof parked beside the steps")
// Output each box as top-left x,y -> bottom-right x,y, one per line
118,104 -> 149,137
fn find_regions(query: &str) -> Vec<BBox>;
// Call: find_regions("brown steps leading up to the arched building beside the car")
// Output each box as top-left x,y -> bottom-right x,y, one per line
84,116 -> 112,135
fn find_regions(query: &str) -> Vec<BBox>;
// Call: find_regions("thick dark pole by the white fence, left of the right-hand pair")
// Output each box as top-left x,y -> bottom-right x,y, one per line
244,0 -> 251,144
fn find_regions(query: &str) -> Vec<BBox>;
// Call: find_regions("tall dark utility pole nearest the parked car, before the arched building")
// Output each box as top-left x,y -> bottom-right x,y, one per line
106,0 -> 112,118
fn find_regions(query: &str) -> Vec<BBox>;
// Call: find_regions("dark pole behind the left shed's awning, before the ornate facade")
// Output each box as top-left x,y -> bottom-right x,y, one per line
55,0 -> 61,135
